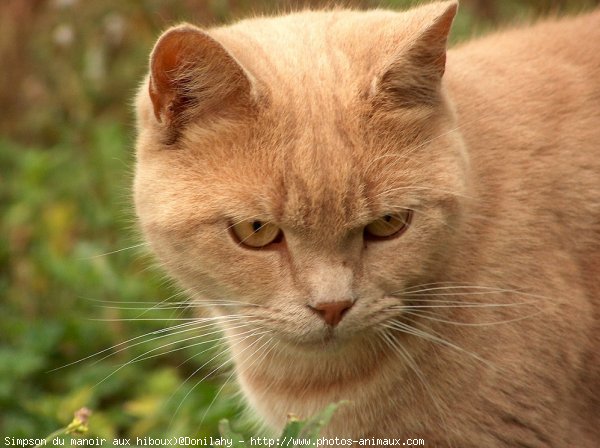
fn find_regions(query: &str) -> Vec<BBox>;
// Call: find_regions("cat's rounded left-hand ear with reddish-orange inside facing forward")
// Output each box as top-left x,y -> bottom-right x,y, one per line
149,24 -> 252,128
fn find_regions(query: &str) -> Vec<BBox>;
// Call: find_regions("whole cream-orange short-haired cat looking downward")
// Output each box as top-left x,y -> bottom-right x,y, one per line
134,0 -> 600,447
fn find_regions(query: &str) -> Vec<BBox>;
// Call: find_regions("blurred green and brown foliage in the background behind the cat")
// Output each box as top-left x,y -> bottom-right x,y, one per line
0,0 -> 598,437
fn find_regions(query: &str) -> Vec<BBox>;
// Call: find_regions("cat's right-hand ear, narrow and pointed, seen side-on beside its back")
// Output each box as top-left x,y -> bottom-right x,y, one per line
372,0 -> 458,109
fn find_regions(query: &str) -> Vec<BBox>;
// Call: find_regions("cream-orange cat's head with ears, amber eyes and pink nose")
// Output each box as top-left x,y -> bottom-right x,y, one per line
135,2 -> 468,349
